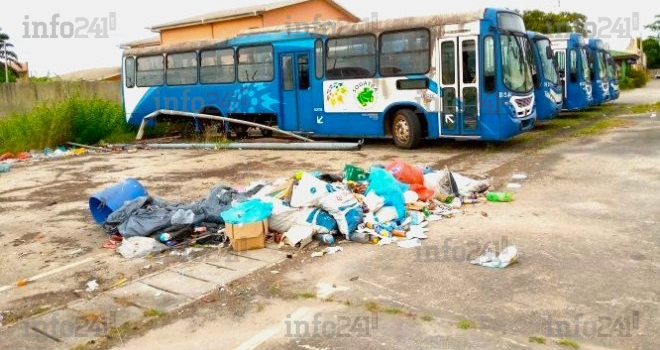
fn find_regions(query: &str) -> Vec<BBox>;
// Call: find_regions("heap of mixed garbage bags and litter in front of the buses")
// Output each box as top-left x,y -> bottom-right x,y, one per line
90,160 -> 496,258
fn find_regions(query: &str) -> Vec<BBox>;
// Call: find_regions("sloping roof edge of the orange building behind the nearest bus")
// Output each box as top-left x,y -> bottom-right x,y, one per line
151,0 -> 359,32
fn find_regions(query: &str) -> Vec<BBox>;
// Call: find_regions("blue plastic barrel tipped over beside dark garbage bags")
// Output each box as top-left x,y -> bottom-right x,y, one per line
89,179 -> 148,225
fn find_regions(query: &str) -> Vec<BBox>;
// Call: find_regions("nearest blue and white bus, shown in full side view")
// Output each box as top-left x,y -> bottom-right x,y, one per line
122,9 -> 536,149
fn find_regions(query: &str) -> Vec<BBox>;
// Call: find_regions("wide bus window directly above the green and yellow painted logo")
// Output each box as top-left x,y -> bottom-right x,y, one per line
325,35 -> 376,79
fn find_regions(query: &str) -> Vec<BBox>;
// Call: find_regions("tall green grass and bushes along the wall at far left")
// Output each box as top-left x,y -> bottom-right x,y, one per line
0,97 -> 130,152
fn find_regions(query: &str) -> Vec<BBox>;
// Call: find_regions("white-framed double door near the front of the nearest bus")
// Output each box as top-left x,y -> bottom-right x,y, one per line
439,36 -> 479,136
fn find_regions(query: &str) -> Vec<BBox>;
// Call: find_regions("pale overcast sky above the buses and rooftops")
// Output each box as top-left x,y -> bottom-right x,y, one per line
0,0 -> 660,76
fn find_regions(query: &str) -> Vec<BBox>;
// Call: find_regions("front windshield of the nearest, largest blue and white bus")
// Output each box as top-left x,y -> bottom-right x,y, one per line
500,34 -> 534,92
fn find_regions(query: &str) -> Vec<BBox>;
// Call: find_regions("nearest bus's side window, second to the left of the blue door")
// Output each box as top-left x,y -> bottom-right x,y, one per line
199,48 -> 236,84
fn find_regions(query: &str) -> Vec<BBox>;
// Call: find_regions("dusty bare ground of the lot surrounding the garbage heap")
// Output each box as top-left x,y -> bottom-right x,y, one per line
0,98 -> 660,349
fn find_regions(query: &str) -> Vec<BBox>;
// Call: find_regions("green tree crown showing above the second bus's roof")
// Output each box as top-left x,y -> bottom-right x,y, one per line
522,10 -> 588,35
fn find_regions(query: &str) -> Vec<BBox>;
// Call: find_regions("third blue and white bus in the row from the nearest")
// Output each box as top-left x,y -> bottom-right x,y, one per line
547,33 -> 593,111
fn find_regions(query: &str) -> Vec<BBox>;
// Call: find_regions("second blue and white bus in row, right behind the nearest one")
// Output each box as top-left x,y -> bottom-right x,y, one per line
527,31 -> 564,120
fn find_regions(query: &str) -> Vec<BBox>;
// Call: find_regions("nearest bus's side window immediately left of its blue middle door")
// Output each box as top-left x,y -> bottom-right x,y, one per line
238,45 -> 273,83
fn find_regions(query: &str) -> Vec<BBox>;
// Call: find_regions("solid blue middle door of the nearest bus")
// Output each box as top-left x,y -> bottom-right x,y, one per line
280,51 -> 316,132
